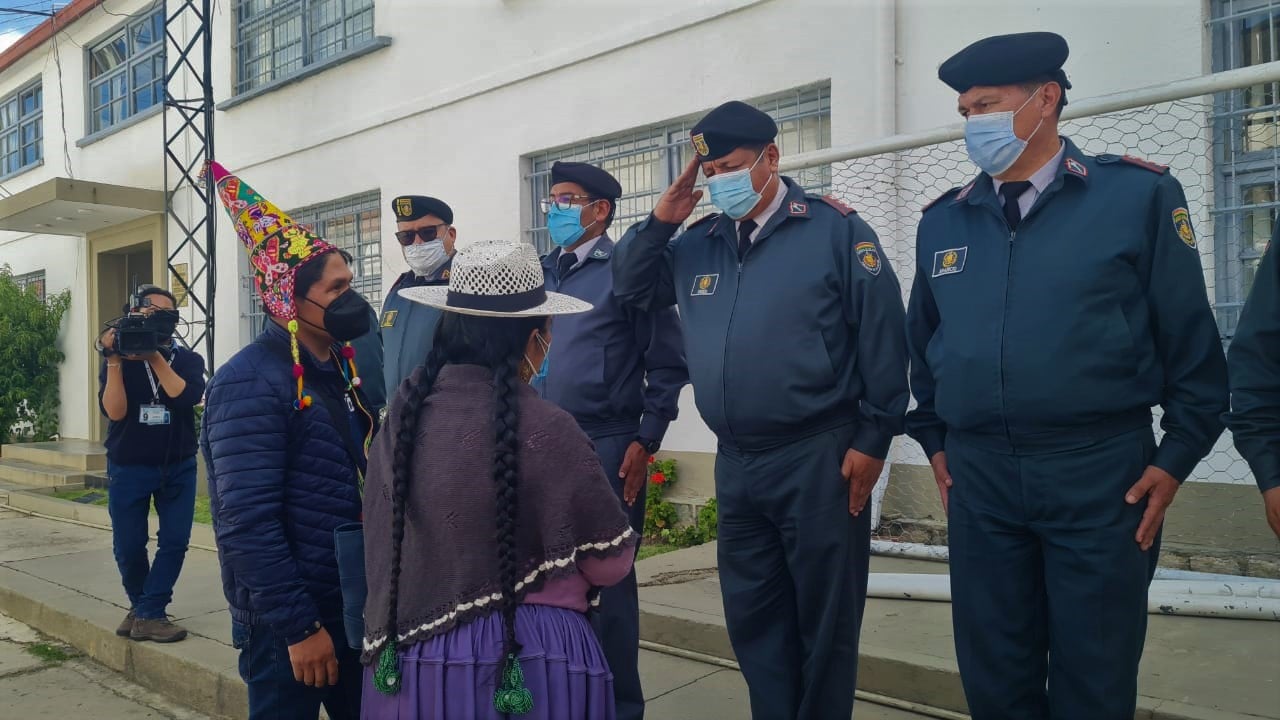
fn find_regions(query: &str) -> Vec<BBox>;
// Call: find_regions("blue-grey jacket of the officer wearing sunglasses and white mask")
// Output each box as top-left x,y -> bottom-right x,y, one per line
379,263 -> 452,397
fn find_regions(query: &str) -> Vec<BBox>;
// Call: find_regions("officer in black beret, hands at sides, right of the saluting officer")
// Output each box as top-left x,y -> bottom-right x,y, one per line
908,32 -> 1226,720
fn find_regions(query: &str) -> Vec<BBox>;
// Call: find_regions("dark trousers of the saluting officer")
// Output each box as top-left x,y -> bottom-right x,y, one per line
716,427 -> 872,720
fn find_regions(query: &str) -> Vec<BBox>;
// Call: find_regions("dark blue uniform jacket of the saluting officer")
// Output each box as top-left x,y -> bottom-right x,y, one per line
613,178 -> 908,457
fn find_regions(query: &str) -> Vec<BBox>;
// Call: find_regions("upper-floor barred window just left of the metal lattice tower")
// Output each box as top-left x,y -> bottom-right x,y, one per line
87,8 -> 165,133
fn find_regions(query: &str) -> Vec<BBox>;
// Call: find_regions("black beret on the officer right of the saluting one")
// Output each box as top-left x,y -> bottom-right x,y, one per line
938,32 -> 1071,92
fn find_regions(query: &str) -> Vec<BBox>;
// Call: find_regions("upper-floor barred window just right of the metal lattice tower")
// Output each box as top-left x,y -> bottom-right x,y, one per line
236,0 -> 374,95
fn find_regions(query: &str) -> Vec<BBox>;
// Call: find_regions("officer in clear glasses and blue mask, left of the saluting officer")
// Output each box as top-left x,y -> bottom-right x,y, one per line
534,163 -> 689,720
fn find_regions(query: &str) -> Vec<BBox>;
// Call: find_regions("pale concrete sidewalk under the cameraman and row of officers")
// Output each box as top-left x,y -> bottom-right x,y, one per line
0,499 -> 1280,720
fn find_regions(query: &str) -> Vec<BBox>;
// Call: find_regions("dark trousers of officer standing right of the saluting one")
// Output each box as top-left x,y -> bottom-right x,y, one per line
946,428 -> 1158,720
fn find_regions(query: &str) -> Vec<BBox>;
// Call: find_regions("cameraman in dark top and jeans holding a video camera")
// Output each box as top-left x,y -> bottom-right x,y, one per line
99,284 -> 205,643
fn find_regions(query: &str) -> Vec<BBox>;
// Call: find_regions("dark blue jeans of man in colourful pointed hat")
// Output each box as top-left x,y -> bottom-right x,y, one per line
232,621 -> 364,720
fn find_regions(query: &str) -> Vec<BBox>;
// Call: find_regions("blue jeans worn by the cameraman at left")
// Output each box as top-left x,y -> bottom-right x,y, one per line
108,457 -> 196,619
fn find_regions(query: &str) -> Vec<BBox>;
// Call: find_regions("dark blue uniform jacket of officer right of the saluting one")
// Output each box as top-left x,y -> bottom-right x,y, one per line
908,140 -> 1226,479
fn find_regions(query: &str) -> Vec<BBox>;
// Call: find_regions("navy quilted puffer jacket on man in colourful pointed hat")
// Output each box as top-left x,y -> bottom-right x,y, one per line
201,323 -> 369,644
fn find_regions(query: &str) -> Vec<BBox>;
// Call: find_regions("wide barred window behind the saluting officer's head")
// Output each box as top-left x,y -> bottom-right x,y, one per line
525,83 -> 831,252
